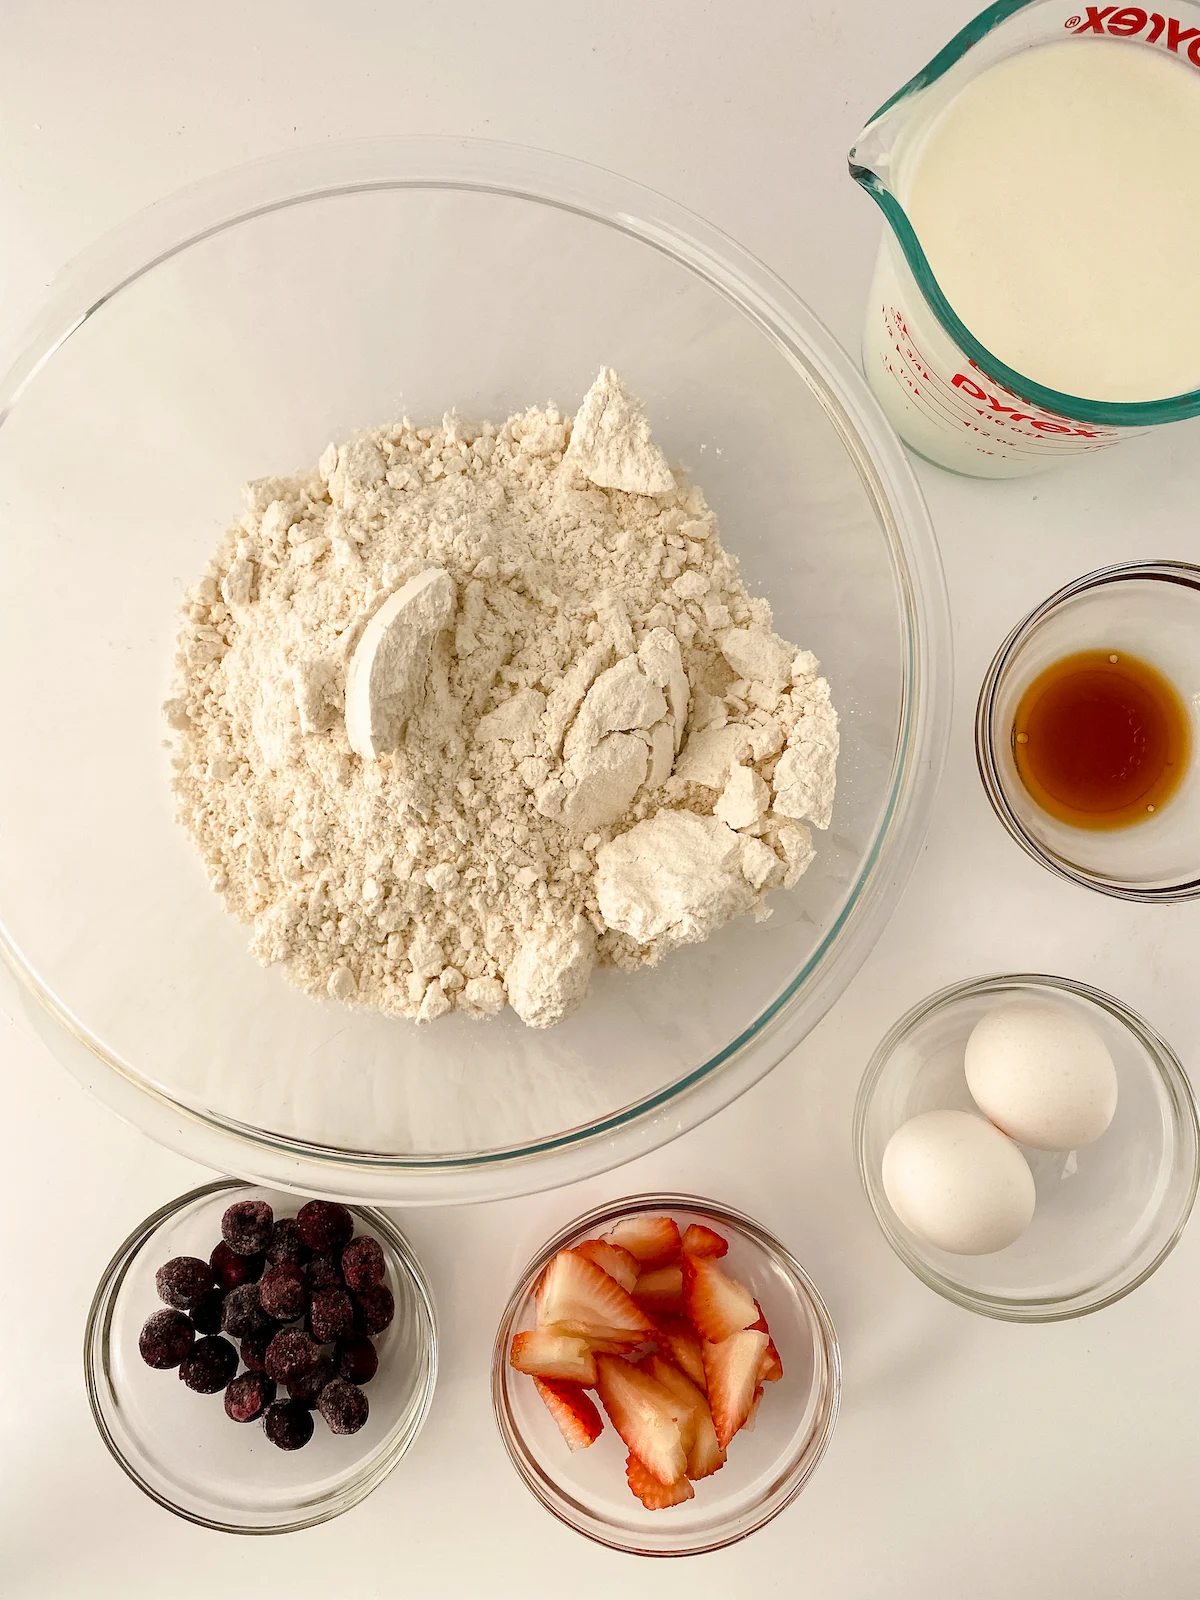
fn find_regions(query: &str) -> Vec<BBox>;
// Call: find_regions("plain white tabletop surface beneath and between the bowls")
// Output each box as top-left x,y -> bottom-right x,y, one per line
0,0 -> 1200,1600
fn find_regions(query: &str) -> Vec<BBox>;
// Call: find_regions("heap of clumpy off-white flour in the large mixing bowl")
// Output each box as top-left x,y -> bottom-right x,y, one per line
165,370 -> 838,1027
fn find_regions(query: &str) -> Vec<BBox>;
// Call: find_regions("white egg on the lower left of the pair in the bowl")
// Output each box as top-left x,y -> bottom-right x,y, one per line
883,1110 -> 1035,1256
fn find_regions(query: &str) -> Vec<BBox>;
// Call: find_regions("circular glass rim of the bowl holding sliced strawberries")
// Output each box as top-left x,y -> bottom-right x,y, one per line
491,1194 -> 842,1560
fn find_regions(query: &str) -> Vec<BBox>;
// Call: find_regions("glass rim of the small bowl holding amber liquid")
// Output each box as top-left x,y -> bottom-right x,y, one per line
974,560 -> 1200,906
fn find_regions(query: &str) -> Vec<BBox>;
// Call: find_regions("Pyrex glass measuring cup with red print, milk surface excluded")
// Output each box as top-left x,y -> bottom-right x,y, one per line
850,0 -> 1200,477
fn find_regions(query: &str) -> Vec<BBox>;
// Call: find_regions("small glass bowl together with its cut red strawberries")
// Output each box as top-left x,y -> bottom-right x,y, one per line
491,1195 -> 842,1555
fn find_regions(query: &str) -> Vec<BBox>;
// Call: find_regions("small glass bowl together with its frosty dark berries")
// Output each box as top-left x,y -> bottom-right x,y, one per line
83,1179 -> 437,1533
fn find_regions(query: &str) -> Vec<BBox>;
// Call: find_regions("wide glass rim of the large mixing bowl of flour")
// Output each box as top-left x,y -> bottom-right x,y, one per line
0,136 -> 952,1205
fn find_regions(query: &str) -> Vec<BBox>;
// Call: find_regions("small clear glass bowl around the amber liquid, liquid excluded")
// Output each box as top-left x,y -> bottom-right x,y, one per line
974,562 -> 1200,904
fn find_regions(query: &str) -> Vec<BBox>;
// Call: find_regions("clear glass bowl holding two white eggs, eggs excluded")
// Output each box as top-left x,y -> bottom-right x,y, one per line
854,973 -> 1200,1322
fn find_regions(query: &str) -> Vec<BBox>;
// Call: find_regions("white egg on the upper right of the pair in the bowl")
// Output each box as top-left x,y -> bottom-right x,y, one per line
966,1000 -> 1117,1150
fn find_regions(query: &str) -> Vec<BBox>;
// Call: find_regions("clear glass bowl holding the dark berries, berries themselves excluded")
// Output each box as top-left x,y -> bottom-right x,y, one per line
83,1179 -> 437,1533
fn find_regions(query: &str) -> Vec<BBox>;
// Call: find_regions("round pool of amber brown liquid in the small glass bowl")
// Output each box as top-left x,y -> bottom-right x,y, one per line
1013,650 -> 1192,829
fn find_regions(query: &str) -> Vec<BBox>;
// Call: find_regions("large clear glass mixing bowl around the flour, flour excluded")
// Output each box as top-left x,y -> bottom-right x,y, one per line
0,139 -> 950,1203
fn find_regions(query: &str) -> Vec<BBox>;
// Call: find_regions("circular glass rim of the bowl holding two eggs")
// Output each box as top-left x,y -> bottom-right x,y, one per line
853,973 -> 1200,1325
